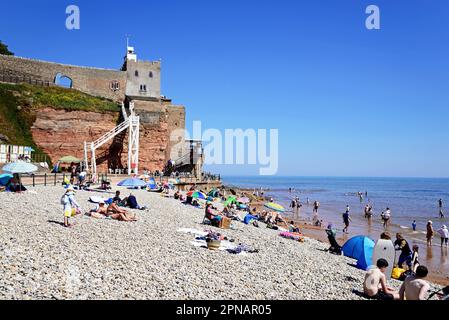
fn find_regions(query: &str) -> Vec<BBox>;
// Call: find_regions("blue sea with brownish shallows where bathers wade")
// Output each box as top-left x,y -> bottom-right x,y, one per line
223,176 -> 449,275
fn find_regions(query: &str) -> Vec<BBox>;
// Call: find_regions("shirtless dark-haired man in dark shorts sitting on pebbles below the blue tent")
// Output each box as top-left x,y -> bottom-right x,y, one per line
363,259 -> 399,300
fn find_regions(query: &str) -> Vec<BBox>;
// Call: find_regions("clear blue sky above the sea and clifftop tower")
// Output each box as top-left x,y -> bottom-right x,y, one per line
0,0 -> 449,177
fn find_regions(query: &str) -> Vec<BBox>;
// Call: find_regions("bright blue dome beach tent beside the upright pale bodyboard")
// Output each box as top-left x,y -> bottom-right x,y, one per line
342,236 -> 374,270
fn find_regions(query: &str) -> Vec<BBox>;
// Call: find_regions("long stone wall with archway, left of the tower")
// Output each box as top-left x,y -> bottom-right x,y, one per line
0,55 -> 126,102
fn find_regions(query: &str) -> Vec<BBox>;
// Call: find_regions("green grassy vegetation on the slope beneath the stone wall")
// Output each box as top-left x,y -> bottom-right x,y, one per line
0,83 -> 120,162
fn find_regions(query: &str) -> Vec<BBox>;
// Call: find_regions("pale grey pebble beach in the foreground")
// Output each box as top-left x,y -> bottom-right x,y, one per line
0,186 -> 437,300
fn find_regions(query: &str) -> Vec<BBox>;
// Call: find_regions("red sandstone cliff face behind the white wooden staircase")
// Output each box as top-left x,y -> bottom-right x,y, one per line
31,108 -> 175,172
